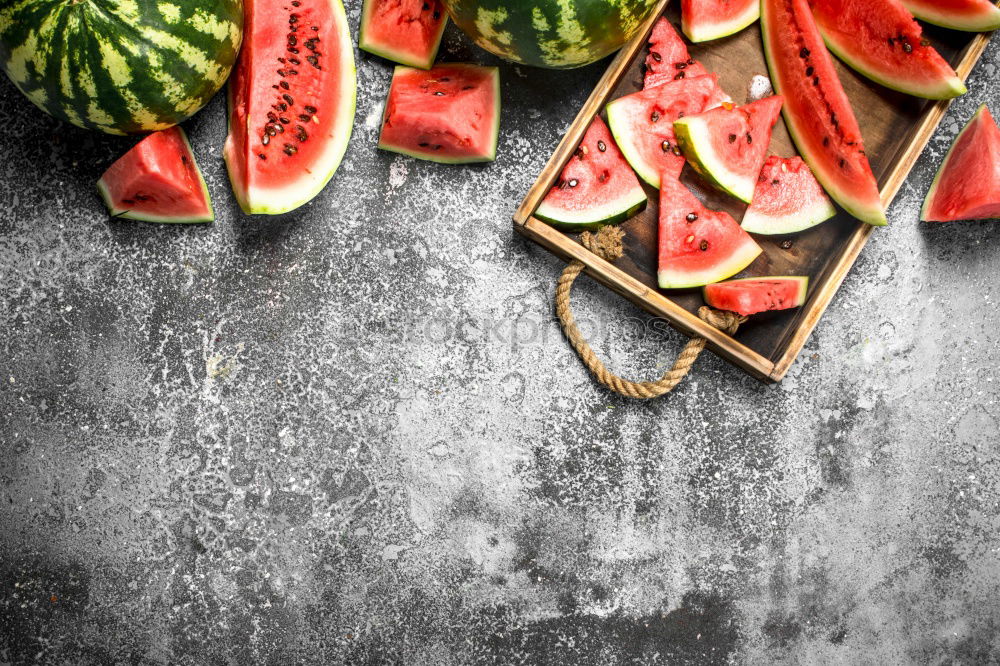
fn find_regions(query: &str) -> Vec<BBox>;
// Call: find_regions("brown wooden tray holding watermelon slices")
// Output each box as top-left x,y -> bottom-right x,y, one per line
514,0 -> 989,382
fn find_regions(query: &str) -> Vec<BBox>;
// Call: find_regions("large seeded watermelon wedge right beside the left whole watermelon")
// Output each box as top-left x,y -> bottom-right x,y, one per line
223,0 -> 356,214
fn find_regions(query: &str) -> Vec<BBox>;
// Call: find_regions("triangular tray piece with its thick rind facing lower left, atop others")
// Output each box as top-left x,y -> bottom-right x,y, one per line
674,95 -> 784,203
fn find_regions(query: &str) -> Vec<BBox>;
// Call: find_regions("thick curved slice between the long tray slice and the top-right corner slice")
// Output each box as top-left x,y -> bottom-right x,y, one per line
810,0 -> 965,99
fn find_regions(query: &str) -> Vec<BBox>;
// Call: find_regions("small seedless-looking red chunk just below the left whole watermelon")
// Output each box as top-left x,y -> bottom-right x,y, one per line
97,126 -> 215,222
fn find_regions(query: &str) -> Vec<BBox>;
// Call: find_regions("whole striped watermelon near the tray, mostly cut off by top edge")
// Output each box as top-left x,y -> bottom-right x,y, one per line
442,0 -> 656,69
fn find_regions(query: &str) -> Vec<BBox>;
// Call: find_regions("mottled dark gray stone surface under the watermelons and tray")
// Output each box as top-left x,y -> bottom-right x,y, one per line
0,3 -> 1000,665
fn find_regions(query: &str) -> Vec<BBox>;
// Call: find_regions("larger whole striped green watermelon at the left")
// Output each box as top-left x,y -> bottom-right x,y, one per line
0,0 -> 243,134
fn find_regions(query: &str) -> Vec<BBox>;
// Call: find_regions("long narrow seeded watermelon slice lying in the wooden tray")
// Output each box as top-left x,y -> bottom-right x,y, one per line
760,0 -> 886,225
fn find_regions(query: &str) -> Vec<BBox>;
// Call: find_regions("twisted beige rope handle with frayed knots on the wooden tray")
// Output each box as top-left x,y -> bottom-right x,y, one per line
556,227 -> 747,399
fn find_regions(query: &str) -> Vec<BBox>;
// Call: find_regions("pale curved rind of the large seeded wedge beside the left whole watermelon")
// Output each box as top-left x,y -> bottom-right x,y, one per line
223,0 -> 358,215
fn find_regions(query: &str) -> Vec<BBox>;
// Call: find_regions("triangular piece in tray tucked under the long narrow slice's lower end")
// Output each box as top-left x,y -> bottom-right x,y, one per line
740,155 -> 837,234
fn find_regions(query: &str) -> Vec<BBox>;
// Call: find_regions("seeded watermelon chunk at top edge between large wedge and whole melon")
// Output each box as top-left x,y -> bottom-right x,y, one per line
358,0 -> 448,69
